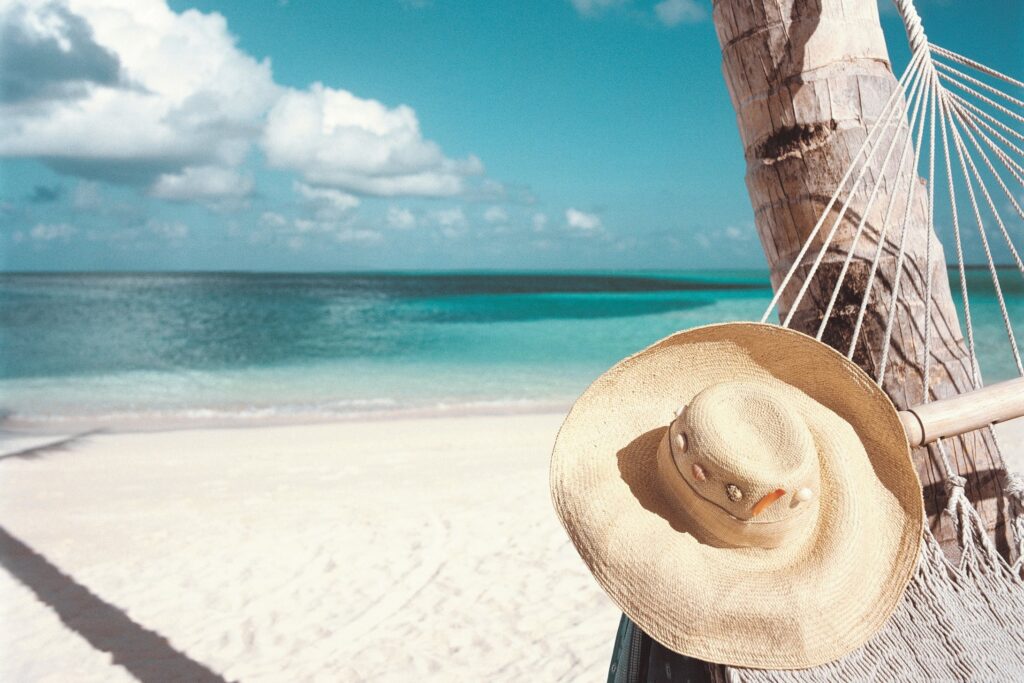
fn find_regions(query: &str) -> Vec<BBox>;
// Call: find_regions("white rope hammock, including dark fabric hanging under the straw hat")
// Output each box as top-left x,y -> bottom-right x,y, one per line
609,0 -> 1024,683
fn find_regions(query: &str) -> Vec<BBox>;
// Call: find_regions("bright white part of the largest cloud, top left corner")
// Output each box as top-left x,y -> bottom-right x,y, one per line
0,0 -> 281,182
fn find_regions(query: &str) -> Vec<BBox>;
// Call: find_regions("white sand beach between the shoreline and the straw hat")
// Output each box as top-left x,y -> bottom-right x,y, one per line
0,415 -> 1024,682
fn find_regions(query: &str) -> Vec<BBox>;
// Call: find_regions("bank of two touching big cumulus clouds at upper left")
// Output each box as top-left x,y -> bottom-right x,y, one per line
0,0 -> 483,209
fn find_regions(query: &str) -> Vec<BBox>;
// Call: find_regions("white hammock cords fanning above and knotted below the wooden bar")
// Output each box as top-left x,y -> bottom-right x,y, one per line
761,0 -> 1024,561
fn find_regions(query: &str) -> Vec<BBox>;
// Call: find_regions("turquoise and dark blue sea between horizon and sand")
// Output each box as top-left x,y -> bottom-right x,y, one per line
0,271 -> 1024,428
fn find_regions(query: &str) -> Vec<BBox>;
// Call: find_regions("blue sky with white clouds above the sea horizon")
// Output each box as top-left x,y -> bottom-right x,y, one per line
0,0 -> 1024,270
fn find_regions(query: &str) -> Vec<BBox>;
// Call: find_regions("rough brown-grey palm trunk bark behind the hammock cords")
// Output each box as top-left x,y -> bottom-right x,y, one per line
714,0 -> 1010,556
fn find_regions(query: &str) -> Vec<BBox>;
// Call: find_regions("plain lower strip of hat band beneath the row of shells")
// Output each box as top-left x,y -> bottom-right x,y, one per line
657,430 -> 818,548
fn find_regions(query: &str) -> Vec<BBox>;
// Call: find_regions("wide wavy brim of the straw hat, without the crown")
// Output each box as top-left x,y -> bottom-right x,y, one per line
551,323 -> 924,669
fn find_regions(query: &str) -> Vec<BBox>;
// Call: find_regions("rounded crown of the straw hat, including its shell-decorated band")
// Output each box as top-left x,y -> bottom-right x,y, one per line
670,382 -> 819,546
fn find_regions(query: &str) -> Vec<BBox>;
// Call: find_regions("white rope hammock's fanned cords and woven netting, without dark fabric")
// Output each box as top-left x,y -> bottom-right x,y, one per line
713,0 -> 1024,681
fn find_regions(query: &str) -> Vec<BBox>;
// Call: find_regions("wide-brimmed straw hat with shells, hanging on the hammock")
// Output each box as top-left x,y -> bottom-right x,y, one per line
551,323 -> 924,669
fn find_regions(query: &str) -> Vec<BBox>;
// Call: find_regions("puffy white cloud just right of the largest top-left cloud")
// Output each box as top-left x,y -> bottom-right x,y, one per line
262,83 -> 483,197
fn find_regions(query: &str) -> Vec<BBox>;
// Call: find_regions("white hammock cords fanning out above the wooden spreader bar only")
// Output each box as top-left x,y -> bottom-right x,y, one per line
761,0 -> 1024,399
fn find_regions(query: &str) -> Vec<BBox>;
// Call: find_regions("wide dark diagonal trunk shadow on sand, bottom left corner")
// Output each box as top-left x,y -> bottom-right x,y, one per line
0,526 -> 227,683
